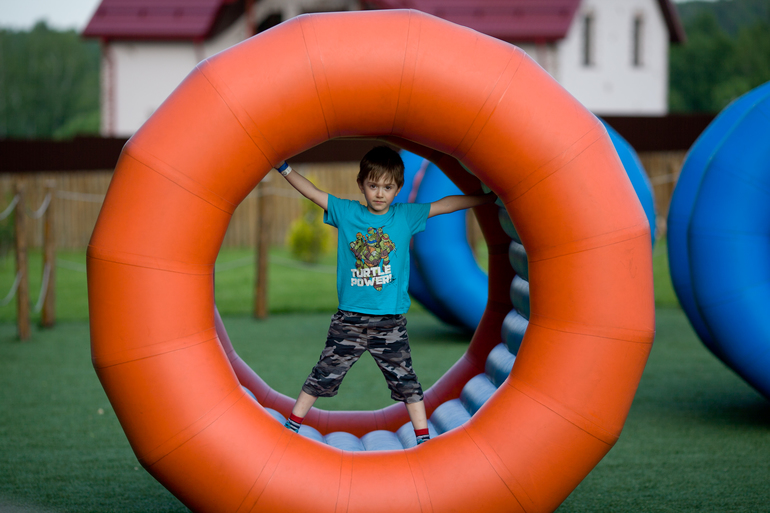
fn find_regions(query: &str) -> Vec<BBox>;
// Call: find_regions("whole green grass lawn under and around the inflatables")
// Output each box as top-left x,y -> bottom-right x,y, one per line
0,241 -> 770,512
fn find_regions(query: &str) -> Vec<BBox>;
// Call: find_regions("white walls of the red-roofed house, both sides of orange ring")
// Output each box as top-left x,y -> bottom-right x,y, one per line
102,0 -> 668,136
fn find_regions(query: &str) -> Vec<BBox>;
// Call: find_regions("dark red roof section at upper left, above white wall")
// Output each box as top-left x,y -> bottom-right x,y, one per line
83,0 -> 237,39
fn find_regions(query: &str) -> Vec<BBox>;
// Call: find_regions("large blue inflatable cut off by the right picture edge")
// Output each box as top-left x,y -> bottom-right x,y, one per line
667,83 -> 770,398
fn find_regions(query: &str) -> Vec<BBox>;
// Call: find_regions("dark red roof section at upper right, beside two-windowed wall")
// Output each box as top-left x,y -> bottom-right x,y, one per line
366,0 -> 684,42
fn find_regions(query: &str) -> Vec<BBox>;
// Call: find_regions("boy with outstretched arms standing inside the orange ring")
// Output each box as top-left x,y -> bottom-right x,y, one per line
276,146 -> 497,444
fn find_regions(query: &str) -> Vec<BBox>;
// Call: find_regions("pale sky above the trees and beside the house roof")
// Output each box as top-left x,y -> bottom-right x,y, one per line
0,0 -> 712,30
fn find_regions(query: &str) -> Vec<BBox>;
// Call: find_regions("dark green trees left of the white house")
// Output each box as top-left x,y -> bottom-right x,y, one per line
0,22 -> 100,138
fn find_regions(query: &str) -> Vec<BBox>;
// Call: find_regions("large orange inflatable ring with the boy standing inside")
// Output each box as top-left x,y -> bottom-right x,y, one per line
88,10 -> 654,513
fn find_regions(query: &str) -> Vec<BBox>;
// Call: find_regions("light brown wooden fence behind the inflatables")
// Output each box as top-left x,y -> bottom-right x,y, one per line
0,151 -> 685,249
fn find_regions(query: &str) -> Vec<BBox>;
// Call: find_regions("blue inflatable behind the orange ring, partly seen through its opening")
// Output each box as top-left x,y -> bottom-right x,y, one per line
395,121 -> 655,332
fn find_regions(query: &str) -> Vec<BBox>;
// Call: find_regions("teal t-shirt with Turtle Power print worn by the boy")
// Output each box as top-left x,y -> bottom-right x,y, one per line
324,194 -> 430,315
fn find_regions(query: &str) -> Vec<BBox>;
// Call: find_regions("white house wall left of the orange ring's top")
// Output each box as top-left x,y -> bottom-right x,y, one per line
102,17 -> 246,137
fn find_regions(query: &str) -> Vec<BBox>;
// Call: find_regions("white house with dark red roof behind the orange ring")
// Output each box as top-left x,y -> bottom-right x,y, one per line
83,0 -> 684,136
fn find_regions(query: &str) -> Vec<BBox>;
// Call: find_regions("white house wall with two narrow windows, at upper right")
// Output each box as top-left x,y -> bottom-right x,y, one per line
554,0 -> 669,116
